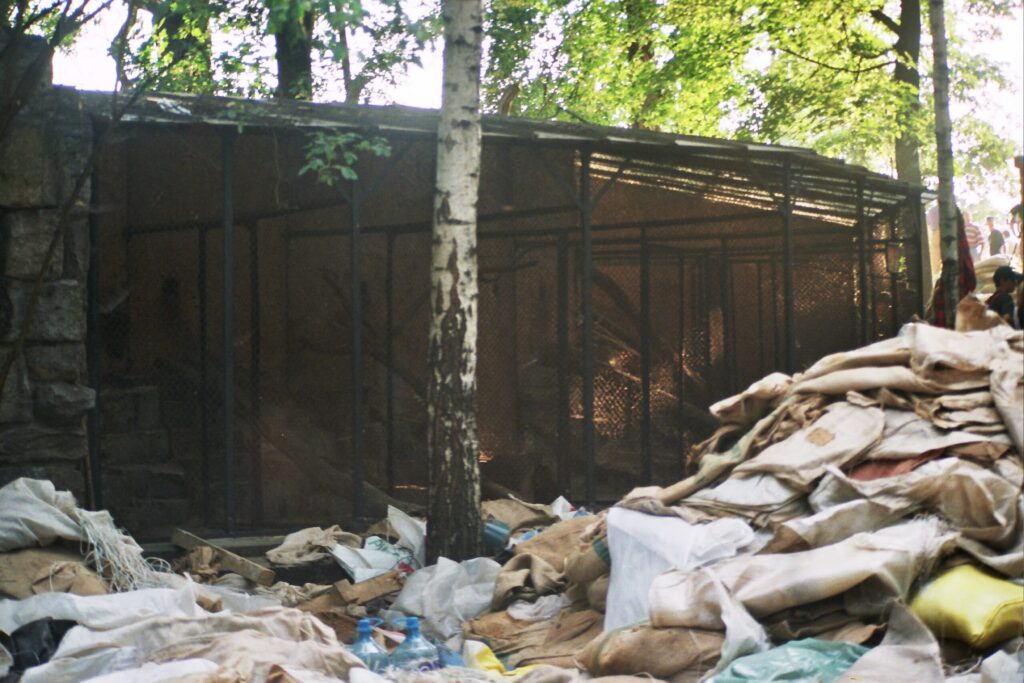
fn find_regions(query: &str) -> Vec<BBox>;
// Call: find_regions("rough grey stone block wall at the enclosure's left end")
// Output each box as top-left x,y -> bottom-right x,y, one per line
0,31 -> 94,503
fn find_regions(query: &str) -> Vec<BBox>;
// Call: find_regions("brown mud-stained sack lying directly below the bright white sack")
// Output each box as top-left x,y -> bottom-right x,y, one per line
577,624 -> 725,681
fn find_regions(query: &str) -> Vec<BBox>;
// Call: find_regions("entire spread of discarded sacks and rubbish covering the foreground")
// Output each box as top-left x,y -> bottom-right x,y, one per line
0,324 -> 1024,683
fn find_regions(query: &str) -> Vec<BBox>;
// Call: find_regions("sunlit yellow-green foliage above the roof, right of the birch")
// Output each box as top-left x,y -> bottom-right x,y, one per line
483,0 -> 1019,191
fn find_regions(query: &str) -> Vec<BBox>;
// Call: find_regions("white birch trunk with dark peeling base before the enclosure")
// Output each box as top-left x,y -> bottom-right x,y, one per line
427,0 -> 482,561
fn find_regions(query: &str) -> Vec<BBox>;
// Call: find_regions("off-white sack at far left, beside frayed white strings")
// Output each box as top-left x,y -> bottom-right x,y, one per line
0,477 -> 85,552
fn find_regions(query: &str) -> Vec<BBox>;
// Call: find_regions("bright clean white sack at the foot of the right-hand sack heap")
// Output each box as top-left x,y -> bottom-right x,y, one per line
604,508 -> 754,631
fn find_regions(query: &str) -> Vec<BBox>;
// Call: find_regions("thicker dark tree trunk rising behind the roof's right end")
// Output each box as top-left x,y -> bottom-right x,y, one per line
893,0 -> 938,301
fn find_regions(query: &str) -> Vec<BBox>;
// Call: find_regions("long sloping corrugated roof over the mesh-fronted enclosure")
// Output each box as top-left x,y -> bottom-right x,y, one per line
78,91 -> 926,225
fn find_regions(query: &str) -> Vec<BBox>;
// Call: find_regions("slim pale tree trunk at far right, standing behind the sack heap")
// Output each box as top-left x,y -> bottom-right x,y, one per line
928,0 -> 959,328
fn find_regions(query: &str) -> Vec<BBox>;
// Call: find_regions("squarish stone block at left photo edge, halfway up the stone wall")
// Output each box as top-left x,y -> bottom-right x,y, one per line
0,210 -> 65,281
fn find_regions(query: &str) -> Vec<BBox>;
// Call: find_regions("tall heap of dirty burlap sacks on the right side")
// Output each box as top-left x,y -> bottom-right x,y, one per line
465,324 -> 1024,683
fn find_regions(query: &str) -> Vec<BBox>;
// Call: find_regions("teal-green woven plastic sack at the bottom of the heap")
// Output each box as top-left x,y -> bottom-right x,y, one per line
711,638 -> 867,683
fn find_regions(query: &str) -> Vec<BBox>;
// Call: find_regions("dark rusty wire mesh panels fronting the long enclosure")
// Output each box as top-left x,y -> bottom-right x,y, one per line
95,126 -> 920,529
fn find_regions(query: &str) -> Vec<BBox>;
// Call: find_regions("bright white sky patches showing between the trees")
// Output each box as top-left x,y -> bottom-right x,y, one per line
53,0 -> 1024,208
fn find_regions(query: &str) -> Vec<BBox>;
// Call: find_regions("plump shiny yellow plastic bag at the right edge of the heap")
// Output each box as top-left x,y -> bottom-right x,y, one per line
910,564 -> 1024,649
